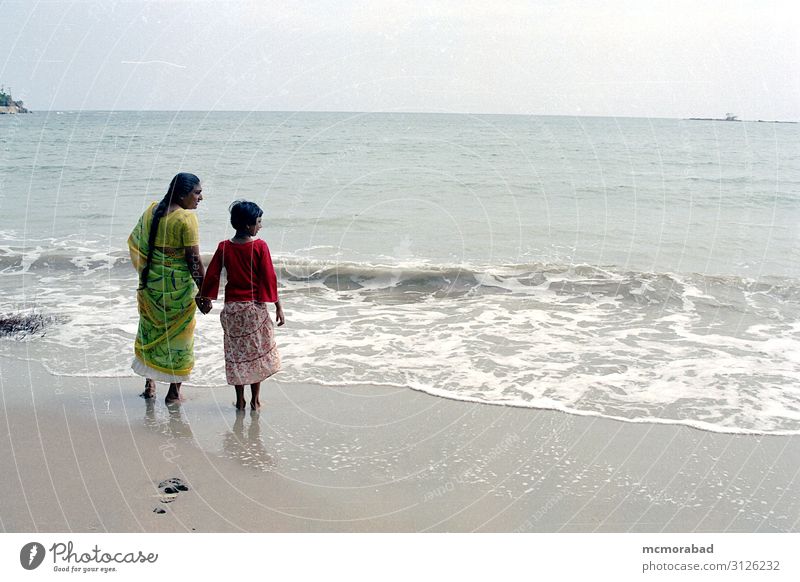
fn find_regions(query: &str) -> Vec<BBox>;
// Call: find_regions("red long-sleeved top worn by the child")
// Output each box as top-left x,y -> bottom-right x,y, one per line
200,238 -> 278,303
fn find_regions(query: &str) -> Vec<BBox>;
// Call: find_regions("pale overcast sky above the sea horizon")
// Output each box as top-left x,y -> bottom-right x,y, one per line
0,0 -> 800,120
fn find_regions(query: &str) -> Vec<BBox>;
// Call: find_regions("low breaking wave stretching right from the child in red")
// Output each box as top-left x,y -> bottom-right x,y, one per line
276,259 -> 800,309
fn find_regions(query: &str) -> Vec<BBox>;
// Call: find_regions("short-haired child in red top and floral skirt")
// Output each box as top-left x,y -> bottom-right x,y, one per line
198,200 -> 284,410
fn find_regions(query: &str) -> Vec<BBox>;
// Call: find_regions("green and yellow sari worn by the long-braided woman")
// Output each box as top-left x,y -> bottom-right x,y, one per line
128,204 -> 197,382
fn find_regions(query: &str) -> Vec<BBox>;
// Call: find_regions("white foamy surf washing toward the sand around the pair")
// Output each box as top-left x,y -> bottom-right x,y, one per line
3,249 -> 800,433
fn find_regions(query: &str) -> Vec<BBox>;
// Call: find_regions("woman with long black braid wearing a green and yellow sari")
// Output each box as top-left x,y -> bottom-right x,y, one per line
128,173 -> 208,404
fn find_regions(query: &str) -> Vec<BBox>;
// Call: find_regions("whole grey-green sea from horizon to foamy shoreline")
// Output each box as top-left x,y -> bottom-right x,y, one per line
0,111 -> 800,434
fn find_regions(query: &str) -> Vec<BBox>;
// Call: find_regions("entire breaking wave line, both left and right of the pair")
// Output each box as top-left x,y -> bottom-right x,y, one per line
0,245 -> 800,307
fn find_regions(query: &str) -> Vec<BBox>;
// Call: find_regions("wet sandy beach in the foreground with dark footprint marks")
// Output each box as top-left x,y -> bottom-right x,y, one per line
0,357 -> 800,532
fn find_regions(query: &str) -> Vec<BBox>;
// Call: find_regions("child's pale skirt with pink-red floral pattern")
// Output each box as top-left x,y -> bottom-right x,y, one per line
219,301 -> 281,385
